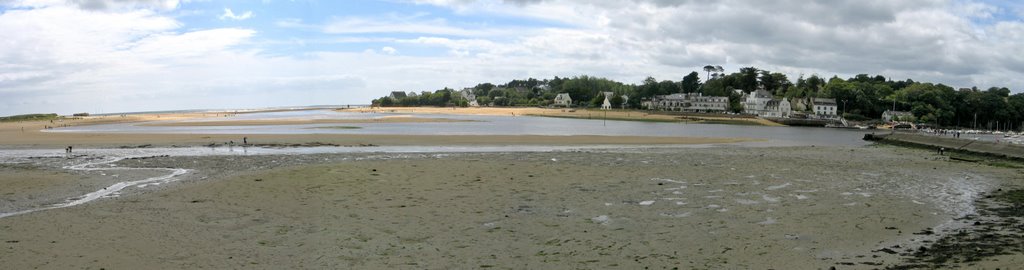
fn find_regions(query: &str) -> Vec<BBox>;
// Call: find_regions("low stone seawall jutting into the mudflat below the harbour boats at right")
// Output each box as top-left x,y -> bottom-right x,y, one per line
864,132 -> 1024,160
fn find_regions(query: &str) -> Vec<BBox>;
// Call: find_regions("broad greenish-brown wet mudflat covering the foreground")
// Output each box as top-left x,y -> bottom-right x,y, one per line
0,146 -> 1022,269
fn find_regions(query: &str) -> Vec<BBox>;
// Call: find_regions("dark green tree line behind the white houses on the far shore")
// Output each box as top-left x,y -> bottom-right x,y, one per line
374,65 -> 1024,129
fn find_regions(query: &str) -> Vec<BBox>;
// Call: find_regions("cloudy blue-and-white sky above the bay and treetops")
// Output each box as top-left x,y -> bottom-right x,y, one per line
0,0 -> 1024,116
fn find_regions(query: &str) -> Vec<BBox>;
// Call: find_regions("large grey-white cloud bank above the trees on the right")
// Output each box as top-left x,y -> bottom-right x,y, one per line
403,0 -> 1024,91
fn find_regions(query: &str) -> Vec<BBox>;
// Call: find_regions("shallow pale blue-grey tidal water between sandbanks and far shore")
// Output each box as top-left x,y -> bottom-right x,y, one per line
49,110 -> 868,146
